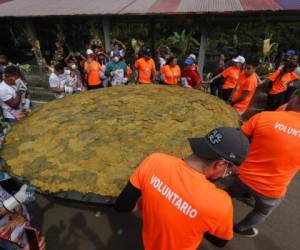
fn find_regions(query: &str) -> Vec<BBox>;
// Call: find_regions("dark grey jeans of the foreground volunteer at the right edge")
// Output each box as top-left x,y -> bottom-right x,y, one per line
226,178 -> 284,231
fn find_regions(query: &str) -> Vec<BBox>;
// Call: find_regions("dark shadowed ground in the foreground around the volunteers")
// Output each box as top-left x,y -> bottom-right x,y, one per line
31,172 -> 300,250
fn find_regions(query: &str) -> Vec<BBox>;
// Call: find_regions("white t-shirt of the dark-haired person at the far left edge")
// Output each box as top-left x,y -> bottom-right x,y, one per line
0,81 -> 21,119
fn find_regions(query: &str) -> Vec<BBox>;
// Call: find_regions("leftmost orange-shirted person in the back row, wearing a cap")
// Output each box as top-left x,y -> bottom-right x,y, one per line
84,49 -> 103,89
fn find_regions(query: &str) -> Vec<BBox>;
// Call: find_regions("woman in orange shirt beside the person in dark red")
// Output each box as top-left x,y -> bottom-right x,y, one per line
160,56 -> 181,85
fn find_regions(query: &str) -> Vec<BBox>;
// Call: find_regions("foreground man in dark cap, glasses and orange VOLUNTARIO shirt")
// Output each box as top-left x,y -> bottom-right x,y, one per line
115,128 -> 249,250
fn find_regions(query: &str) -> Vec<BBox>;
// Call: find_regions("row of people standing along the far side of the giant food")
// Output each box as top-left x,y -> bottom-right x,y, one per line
49,41 -> 300,120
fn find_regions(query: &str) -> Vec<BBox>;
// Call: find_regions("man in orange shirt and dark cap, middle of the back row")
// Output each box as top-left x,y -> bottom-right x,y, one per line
134,49 -> 155,84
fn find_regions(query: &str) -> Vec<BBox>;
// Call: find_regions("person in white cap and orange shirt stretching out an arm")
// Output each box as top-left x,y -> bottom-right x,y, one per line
208,56 -> 246,101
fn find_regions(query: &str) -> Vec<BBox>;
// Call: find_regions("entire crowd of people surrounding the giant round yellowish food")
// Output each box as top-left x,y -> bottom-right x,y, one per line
0,41 -> 300,250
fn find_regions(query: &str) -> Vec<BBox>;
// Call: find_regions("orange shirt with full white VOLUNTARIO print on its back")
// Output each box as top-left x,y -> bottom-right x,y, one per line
130,153 -> 233,250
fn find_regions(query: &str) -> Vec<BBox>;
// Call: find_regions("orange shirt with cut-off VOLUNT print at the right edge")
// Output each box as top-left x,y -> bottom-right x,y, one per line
239,111 -> 300,198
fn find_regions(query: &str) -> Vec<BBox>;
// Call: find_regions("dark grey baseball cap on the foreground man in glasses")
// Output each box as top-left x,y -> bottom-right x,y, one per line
188,127 -> 249,166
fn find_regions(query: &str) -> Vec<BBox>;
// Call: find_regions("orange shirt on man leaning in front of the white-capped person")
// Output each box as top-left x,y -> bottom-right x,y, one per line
231,72 -> 258,112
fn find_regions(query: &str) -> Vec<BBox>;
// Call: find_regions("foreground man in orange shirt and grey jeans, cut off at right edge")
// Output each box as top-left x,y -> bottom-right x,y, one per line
227,92 -> 300,237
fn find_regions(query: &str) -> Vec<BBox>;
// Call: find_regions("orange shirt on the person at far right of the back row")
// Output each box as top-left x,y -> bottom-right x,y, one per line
268,69 -> 299,95
